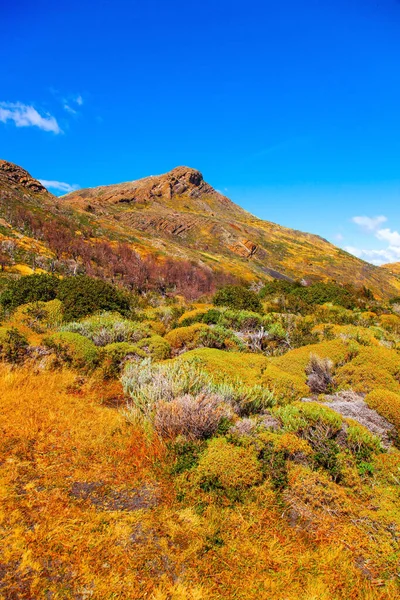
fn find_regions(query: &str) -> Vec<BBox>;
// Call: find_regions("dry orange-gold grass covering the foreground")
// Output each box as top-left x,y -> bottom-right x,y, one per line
0,366 -> 399,600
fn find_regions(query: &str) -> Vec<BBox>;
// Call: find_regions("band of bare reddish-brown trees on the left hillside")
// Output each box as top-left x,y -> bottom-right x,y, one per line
0,207 -> 235,300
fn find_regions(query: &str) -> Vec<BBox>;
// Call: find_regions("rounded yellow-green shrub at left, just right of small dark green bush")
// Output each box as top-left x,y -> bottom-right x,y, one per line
43,331 -> 99,370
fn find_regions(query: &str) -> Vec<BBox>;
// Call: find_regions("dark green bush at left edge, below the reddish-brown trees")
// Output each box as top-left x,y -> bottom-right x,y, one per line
0,274 -> 60,310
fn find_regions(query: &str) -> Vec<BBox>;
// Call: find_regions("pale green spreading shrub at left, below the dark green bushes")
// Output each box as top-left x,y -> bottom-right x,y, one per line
62,312 -> 149,346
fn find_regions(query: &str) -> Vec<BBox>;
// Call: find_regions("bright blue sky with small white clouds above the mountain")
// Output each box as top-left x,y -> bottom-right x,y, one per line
0,0 -> 400,263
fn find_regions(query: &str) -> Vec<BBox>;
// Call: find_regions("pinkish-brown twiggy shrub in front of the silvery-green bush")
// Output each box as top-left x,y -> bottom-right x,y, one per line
154,393 -> 233,440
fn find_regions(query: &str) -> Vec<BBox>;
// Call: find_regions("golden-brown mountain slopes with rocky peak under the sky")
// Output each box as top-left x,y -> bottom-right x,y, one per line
0,161 -> 400,296
